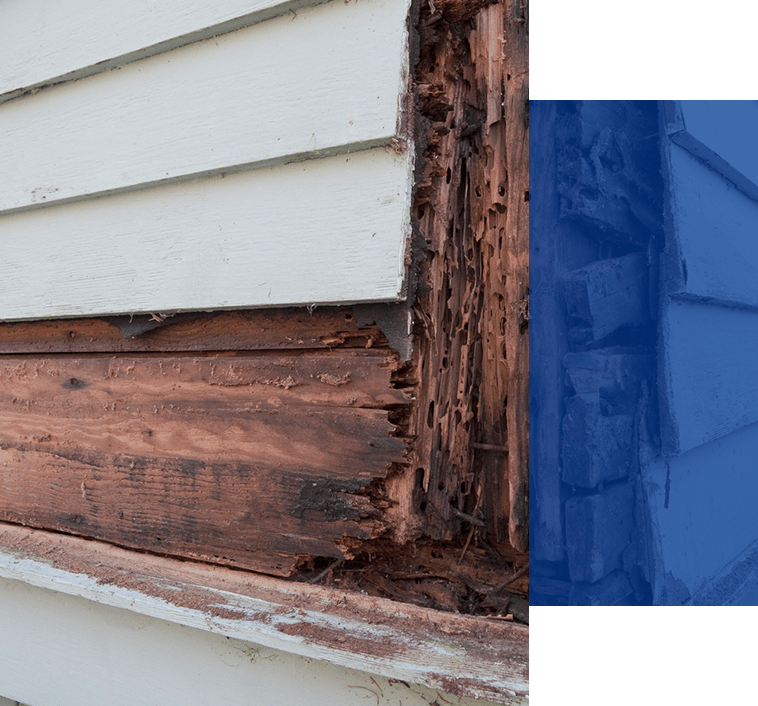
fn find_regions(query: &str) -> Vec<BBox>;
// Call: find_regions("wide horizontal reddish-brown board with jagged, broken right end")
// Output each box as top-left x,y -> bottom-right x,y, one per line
0,351 -> 407,575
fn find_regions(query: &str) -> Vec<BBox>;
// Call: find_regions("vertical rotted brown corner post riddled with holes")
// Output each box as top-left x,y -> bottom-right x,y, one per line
411,0 -> 529,550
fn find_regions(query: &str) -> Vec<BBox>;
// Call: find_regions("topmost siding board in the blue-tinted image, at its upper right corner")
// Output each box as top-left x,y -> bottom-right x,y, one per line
667,100 -> 758,199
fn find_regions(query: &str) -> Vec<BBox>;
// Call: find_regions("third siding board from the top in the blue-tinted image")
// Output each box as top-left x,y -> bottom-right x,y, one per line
659,301 -> 758,455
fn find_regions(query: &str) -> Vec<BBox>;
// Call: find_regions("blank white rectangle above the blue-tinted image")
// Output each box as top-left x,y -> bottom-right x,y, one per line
529,0 -> 758,100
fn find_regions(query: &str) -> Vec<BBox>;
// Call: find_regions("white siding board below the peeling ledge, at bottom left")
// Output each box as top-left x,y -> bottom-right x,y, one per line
0,579 -> 512,706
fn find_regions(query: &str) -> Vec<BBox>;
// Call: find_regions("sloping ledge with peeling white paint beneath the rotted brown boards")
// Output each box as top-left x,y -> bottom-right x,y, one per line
0,523 -> 529,706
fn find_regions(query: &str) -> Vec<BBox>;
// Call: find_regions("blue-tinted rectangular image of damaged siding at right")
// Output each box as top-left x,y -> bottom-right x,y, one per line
529,101 -> 758,605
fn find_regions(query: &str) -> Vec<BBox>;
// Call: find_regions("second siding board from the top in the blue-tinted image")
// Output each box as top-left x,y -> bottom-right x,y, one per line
665,144 -> 758,307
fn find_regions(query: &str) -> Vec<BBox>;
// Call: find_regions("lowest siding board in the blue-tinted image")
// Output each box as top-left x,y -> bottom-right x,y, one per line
640,418 -> 758,605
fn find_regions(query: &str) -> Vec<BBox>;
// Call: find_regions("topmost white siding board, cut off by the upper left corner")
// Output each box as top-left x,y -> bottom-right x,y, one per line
0,0 -> 318,102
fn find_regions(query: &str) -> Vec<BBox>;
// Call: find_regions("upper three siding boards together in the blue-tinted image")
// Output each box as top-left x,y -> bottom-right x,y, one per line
659,101 -> 758,455
